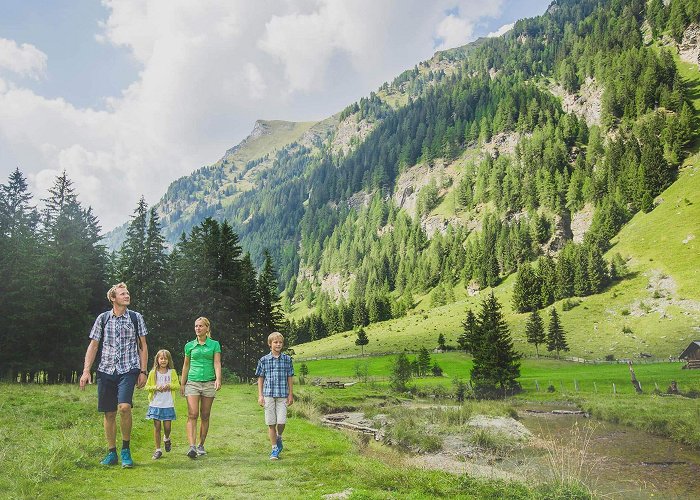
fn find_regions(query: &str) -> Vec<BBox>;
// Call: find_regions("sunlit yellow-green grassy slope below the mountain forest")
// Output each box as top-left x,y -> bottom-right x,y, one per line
294,53 -> 700,359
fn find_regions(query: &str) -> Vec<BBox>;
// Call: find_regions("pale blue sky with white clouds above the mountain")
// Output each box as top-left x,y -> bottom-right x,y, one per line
0,0 -> 549,230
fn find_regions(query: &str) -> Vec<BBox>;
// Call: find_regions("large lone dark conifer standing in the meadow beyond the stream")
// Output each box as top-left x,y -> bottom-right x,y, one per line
471,293 -> 521,398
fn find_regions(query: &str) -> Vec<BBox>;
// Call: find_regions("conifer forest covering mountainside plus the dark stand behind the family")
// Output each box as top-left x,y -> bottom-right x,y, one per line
0,0 -> 700,382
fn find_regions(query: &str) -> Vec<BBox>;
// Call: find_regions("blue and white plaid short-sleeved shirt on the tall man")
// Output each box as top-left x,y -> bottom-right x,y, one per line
90,309 -> 148,375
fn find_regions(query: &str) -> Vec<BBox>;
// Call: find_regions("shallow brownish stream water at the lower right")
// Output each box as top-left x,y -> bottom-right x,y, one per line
502,411 -> 700,499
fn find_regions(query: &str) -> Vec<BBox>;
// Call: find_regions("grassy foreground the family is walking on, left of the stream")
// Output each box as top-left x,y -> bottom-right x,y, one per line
0,384 -> 584,499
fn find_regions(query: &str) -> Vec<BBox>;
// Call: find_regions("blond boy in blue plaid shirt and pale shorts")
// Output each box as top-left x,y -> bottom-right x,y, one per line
255,332 -> 294,460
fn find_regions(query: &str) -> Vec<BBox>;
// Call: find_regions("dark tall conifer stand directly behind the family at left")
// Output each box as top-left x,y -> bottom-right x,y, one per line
0,170 -> 282,383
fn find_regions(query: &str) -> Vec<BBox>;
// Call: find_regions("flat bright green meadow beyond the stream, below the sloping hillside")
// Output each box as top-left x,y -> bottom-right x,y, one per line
297,352 -> 700,448
